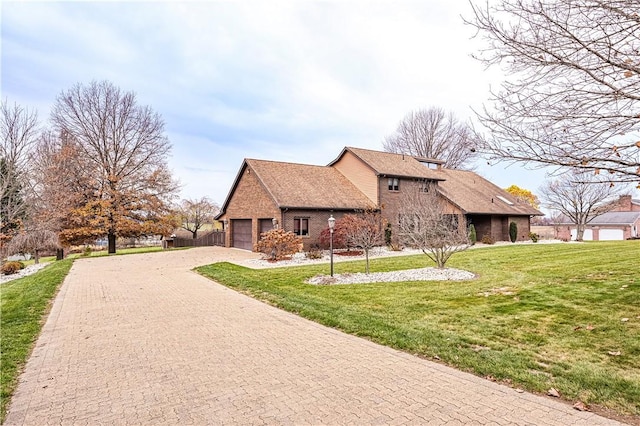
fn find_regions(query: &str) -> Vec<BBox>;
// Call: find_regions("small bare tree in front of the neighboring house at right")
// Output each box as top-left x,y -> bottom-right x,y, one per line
541,172 -> 618,241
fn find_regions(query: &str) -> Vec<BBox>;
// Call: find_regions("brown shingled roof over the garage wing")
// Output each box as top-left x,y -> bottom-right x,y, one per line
245,159 -> 375,210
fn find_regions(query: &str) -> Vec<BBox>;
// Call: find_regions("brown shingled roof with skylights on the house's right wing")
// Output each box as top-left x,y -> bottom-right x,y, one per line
438,169 -> 543,216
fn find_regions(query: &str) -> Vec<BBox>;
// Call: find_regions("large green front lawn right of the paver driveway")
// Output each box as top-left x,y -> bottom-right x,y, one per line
198,241 -> 640,416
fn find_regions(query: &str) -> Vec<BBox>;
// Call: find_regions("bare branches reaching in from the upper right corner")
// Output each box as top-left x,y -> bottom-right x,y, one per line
467,0 -> 640,182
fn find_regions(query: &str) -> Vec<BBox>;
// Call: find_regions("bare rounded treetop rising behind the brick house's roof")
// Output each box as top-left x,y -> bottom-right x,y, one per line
383,107 -> 477,169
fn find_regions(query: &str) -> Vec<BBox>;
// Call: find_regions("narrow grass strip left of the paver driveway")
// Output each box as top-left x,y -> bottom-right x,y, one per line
0,260 -> 73,422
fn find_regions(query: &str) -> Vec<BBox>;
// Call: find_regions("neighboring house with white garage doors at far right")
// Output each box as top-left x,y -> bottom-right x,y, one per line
555,195 -> 640,241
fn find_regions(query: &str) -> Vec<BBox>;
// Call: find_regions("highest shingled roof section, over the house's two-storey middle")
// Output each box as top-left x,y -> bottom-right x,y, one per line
329,146 -> 442,180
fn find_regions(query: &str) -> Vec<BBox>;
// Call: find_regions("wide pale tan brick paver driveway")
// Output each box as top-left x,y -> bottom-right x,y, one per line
6,248 -> 616,425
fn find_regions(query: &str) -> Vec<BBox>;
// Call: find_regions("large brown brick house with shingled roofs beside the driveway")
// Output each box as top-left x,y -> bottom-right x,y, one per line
216,147 -> 542,250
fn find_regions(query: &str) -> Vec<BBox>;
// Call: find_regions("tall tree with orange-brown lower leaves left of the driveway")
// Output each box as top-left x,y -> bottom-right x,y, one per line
51,81 -> 177,253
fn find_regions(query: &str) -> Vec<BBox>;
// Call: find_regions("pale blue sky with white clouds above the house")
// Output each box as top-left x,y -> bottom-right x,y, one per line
0,0 -> 636,210
